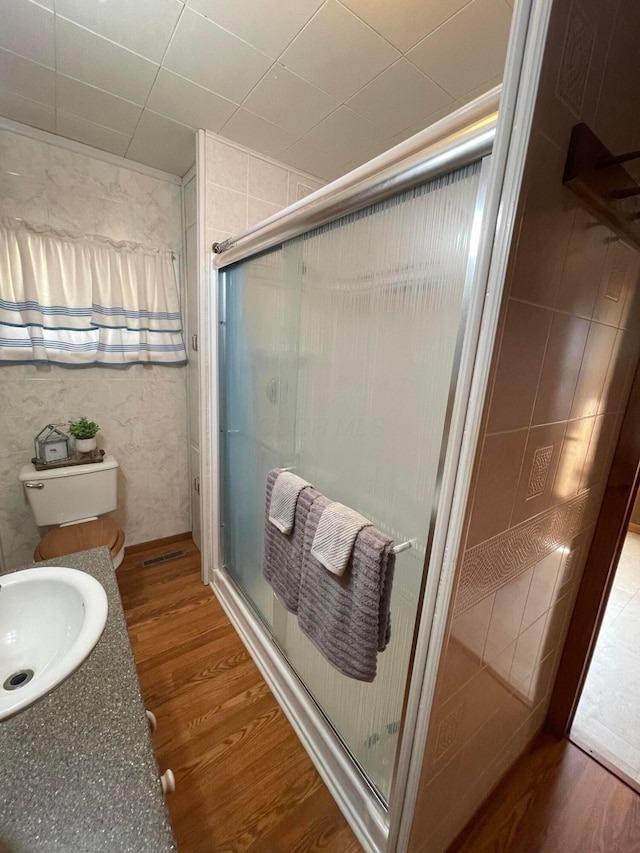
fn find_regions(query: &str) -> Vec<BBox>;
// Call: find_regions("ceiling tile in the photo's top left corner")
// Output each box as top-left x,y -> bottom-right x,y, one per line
0,0 -> 55,68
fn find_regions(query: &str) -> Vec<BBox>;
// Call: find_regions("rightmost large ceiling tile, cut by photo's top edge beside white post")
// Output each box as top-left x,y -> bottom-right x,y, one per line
407,0 -> 511,98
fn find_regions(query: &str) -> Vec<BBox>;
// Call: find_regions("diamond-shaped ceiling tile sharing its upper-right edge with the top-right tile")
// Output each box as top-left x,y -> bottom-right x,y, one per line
347,59 -> 453,136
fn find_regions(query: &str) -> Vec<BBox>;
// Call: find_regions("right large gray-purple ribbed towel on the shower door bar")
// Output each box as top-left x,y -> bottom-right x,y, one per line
298,492 -> 395,681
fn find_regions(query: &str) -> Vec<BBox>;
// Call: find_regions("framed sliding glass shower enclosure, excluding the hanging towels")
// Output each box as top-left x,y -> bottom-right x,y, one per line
214,86 -> 497,849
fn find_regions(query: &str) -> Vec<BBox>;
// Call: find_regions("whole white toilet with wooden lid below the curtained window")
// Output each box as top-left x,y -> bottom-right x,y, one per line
18,456 -> 124,569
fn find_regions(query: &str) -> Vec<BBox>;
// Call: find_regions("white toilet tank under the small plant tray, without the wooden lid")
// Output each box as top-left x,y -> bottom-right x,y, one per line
18,456 -> 118,527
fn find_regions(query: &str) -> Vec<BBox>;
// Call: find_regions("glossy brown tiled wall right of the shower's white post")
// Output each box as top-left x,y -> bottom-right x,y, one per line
410,0 -> 640,853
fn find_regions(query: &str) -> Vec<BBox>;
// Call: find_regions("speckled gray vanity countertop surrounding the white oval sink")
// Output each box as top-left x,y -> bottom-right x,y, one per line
0,548 -> 176,853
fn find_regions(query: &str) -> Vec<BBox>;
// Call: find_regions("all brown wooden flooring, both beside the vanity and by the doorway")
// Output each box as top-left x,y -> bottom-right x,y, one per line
117,540 -> 640,853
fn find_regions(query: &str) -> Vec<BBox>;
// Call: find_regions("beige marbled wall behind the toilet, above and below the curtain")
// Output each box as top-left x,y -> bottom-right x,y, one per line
0,125 -> 191,568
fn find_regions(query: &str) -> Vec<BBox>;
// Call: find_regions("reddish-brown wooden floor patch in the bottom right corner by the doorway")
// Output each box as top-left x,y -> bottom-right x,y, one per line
458,734 -> 640,853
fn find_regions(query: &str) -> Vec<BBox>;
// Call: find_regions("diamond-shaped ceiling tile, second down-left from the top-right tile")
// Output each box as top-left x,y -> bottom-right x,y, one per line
303,107 -> 384,166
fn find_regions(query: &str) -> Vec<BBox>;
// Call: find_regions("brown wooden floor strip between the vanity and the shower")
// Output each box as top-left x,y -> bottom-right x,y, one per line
117,540 -> 362,853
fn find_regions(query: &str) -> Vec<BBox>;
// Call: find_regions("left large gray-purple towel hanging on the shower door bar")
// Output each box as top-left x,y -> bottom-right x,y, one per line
263,468 -> 320,613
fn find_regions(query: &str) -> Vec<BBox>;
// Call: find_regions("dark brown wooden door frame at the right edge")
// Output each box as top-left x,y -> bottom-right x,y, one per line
545,360 -> 640,738
